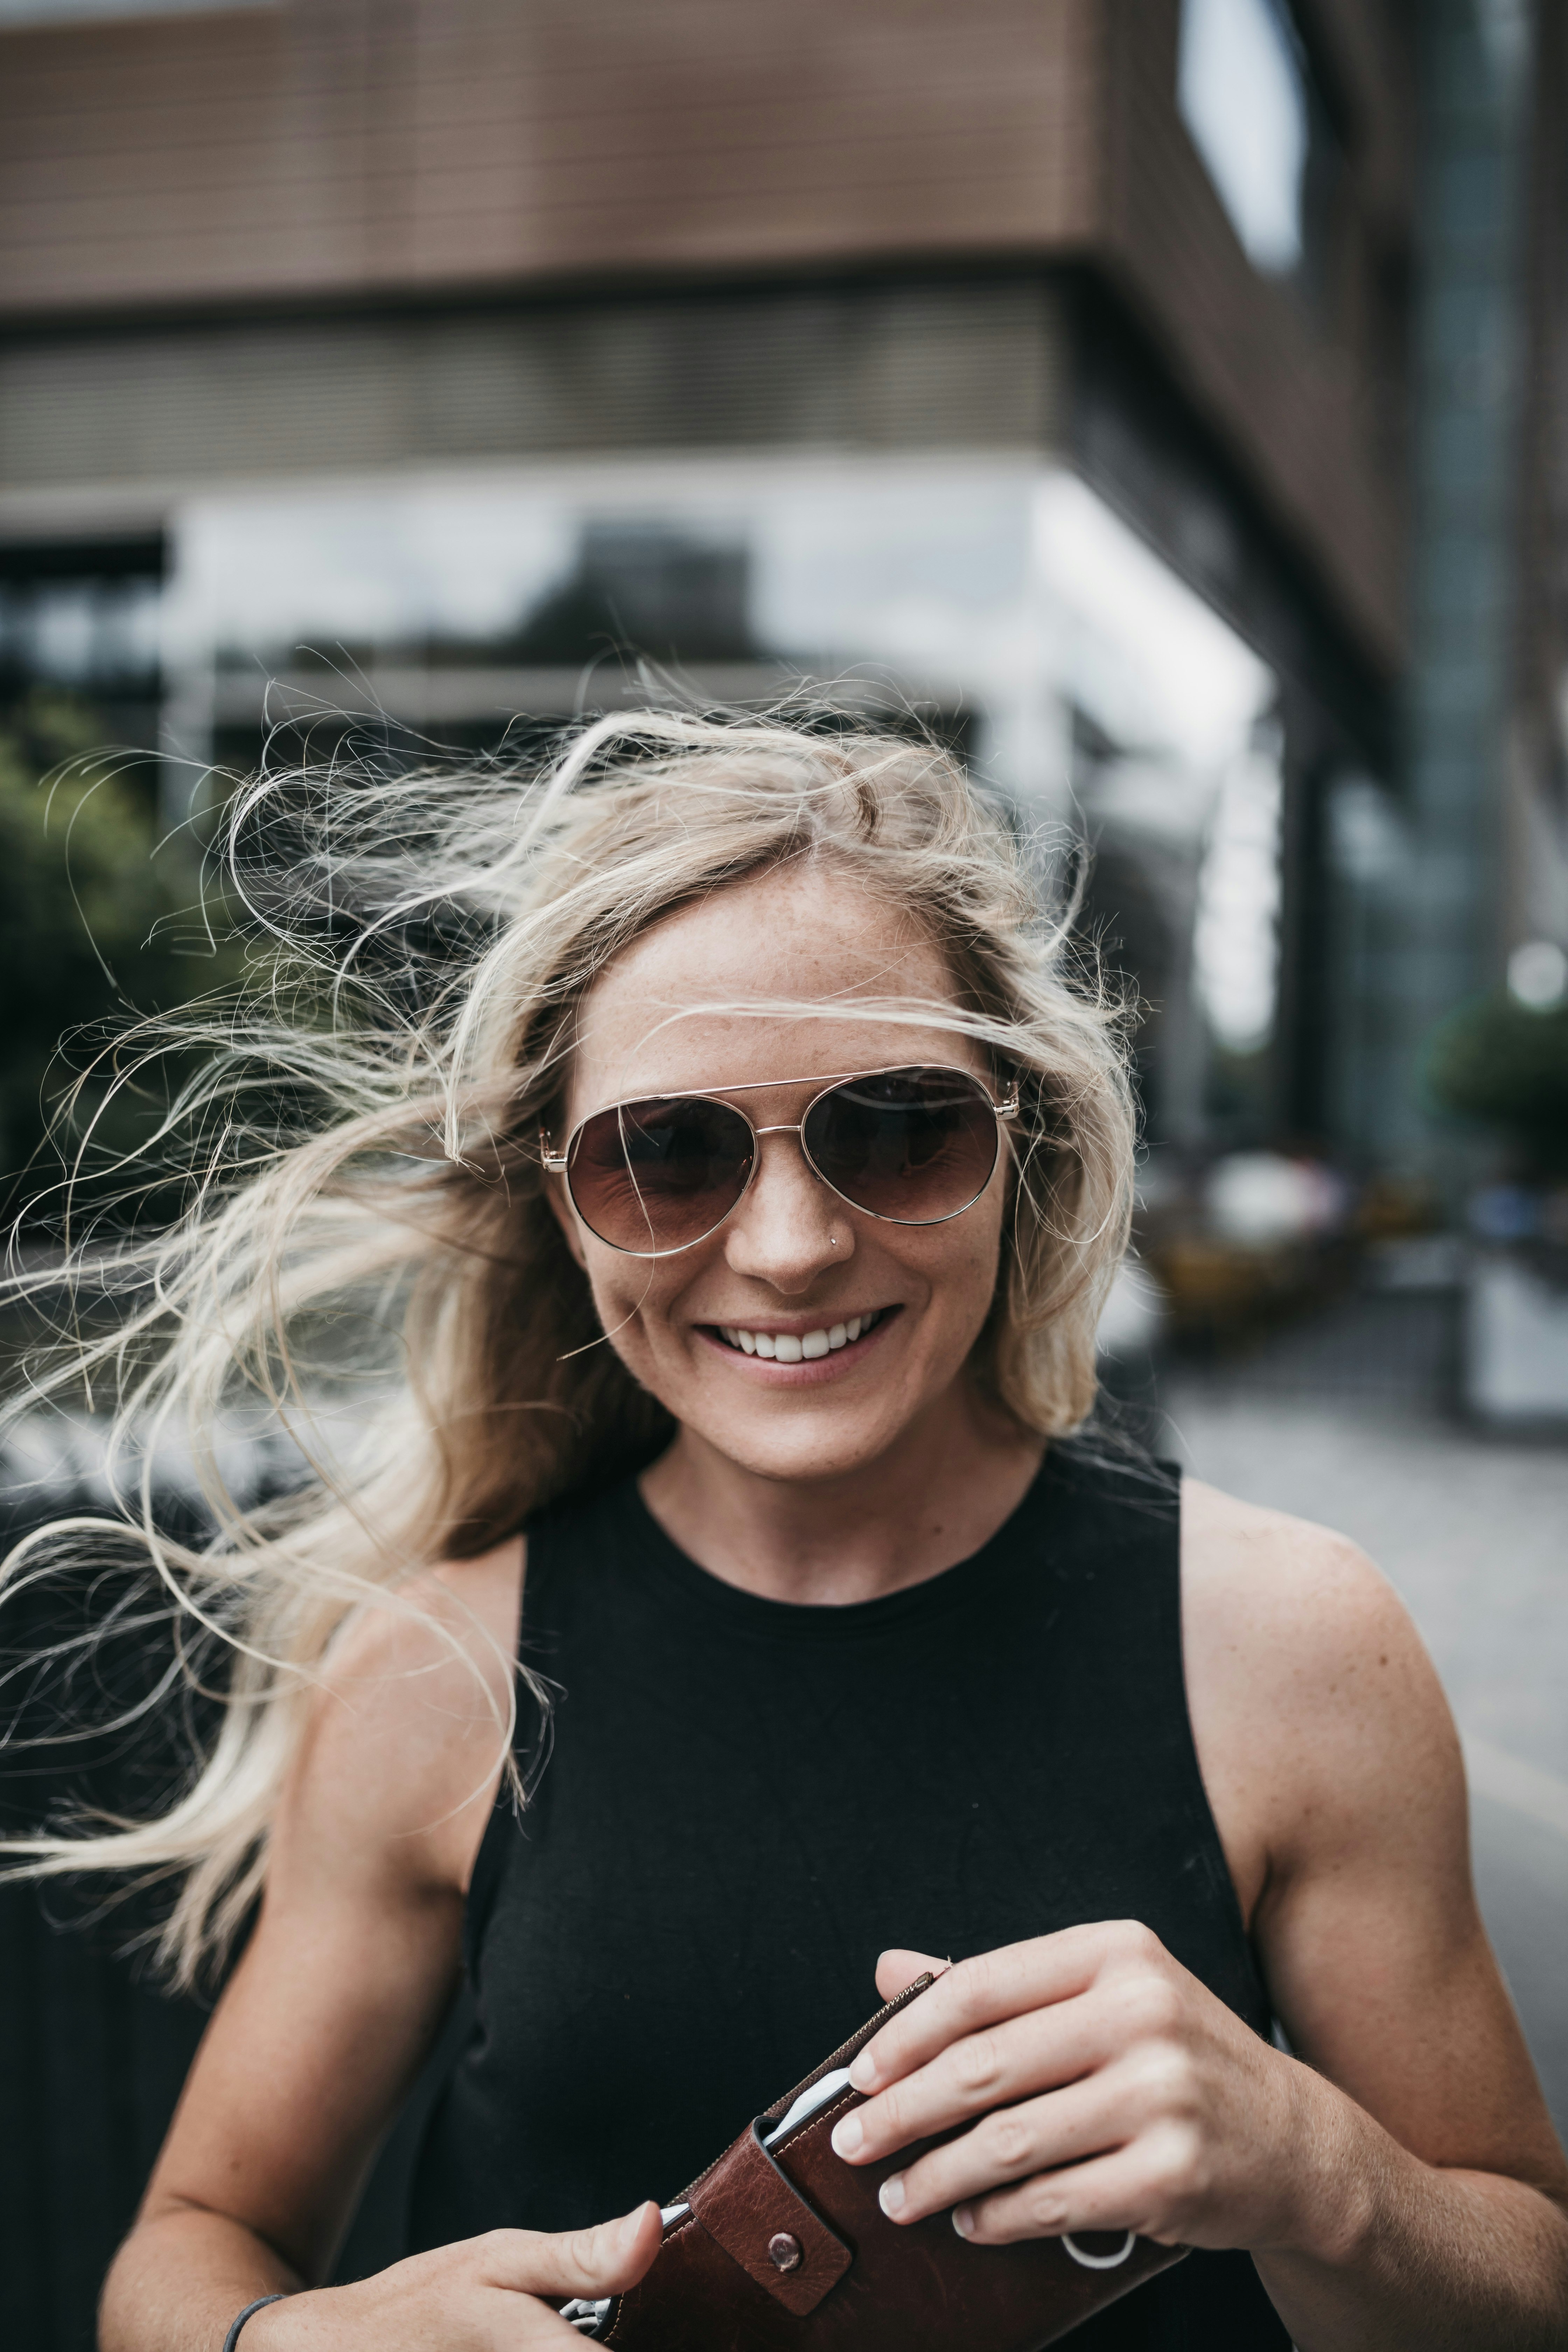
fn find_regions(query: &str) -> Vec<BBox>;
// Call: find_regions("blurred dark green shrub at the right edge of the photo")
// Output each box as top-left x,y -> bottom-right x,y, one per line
1427,990 -> 1568,1176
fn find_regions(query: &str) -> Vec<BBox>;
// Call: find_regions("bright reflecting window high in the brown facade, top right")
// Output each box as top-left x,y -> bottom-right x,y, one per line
1175,0 -> 1314,278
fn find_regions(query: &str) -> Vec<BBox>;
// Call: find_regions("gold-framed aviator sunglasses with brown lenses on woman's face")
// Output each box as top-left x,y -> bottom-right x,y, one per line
538,1063 -> 1018,1258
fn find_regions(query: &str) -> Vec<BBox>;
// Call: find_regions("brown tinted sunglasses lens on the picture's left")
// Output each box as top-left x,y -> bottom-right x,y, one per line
567,1096 -> 755,1256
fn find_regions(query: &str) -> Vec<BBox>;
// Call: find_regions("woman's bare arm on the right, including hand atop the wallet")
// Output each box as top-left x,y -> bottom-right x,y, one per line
834,1489 -> 1568,2352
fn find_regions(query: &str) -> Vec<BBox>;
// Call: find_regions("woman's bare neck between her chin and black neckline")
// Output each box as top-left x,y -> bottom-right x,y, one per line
642,1383 -> 1044,1606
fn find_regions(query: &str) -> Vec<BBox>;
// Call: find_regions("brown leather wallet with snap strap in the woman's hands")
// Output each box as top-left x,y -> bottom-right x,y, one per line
562,1976 -> 1187,2352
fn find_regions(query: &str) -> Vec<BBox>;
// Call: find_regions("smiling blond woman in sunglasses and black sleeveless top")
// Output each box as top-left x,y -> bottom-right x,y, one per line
12,715 -> 1568,2352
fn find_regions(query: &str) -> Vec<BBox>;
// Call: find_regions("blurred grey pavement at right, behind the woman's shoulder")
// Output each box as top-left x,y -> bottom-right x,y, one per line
1157,1294 -> 1568,2136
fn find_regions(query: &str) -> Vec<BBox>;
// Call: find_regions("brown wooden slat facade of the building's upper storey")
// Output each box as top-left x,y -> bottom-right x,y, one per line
0,0 -> 1408,670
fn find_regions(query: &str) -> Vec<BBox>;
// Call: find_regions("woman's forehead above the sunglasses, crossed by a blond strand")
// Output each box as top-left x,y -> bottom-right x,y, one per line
571,866 -> 975,1105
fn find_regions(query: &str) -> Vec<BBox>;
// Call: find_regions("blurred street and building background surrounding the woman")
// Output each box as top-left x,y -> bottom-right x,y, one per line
0,0 -> 1568,2352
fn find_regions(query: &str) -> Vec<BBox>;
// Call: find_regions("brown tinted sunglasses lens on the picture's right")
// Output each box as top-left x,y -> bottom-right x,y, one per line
802,1070 -> 997,1225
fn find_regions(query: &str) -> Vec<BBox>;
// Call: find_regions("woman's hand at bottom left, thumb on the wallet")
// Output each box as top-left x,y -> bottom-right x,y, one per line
240,2202 -> 663,2352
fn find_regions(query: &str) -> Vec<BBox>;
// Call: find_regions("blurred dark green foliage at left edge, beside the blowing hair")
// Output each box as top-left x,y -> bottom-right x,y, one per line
0,689 -> 230,1221
